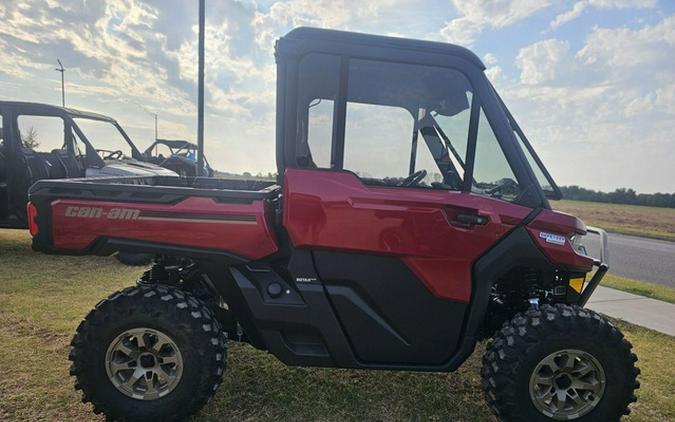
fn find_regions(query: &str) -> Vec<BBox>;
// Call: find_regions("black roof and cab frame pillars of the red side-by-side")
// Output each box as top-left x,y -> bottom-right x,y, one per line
275,28 -> 560,208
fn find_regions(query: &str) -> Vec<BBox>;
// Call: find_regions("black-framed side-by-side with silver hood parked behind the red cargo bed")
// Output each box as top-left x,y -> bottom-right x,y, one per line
0,101 -> 176,265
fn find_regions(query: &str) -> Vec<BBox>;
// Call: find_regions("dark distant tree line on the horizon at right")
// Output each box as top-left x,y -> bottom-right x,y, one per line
560,186 -> 675,208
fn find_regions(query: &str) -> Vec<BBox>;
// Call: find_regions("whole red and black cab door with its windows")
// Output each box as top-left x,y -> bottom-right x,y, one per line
283,54 -> 532,365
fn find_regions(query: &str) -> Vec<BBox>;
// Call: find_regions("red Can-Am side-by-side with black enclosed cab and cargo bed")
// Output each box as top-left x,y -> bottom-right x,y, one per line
28,28 -> 639,421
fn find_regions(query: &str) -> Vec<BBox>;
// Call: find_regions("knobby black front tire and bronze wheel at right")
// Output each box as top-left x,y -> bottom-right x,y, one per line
482,305 -> 640,422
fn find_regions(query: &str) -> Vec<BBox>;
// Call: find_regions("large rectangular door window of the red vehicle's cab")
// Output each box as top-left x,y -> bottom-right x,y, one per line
343,59 -> 472,190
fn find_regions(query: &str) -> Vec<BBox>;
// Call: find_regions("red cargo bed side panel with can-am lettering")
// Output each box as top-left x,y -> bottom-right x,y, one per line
51,197 -> 278,259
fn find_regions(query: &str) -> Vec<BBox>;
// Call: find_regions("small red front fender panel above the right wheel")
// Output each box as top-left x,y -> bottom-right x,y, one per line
527,210 -> 593,272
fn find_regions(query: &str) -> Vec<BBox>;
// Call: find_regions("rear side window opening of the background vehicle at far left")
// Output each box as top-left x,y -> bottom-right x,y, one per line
17,115 -> 66,152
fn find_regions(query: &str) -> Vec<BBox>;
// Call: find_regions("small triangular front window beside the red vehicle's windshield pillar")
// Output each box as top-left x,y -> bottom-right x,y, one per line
472,109 -> 520,201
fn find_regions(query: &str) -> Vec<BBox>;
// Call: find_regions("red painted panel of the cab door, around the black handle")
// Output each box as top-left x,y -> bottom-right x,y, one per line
284,169 -> 531,302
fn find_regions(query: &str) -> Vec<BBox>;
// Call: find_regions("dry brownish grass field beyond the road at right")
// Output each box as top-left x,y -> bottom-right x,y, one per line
551,200 -> 675,241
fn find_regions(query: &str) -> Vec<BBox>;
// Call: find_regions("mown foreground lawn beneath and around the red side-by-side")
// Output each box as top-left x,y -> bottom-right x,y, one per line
0,230 -> 675,421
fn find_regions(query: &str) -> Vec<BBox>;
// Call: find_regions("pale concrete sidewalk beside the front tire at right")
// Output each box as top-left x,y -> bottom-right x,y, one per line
586,286 -> 675,336
